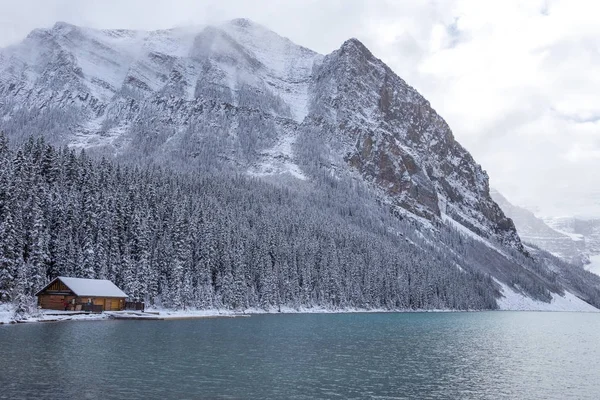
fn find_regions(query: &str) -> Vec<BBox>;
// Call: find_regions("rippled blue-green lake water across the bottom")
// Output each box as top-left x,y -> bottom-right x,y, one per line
0,312 -> 600,399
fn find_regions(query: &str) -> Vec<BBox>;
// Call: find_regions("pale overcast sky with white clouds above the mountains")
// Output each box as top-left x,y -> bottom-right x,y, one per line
0,0 -> 600,216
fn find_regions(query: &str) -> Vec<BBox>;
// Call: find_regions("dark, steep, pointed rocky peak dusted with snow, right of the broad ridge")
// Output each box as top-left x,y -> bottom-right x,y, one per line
309,39 -> 521,248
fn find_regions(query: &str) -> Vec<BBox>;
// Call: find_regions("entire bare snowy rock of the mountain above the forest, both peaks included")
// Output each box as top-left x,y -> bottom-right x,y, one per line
0,20 -> 522,249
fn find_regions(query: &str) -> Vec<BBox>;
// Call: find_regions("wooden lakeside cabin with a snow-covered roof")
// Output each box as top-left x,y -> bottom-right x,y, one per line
35,276 -> 127,312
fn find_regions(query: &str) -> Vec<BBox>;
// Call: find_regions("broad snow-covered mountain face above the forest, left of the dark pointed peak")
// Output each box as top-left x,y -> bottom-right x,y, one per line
0,19 -> 323,184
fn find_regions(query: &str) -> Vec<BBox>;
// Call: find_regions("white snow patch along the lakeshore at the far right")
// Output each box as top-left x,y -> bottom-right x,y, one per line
496,281 -> 600,312
